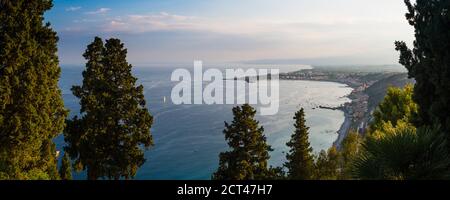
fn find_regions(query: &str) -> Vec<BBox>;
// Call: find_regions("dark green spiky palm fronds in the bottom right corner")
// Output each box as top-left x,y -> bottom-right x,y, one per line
354,125 -> 450,180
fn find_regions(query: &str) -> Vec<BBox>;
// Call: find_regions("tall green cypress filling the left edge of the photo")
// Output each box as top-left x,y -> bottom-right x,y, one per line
0,0 -> 67,179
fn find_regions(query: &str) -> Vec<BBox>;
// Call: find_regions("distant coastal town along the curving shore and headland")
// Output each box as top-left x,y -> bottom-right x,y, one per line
280,69 -> 409,148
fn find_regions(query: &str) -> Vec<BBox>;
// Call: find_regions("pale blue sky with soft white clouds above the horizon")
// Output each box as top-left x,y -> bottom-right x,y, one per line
45,0 -> 414,65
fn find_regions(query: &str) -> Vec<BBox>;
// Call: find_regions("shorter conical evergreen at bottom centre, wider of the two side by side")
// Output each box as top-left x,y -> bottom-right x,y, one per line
212,104 -> 276,180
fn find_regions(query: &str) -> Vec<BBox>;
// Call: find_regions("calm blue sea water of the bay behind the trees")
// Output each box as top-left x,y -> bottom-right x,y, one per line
56,65 -> 352,180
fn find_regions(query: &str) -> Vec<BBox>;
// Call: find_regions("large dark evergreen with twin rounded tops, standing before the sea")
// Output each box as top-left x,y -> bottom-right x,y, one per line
64,37 -> 153,180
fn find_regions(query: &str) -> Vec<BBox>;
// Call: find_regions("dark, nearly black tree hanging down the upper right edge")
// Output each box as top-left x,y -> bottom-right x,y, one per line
395,0 -> 450,134
